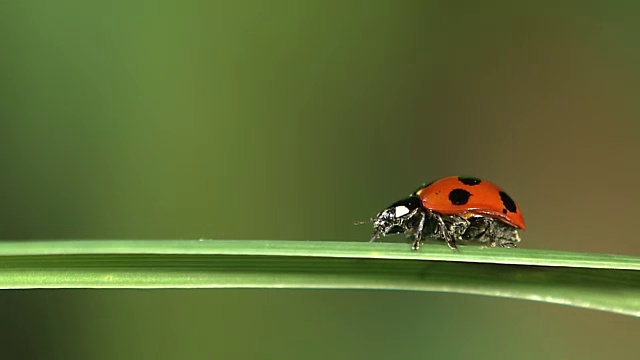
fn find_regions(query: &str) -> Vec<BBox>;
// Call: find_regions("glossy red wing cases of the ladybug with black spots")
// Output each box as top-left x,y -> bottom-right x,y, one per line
416,176 -> 525,230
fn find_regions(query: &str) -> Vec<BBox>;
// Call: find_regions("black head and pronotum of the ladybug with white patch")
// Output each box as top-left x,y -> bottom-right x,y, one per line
369,196 -> 422,241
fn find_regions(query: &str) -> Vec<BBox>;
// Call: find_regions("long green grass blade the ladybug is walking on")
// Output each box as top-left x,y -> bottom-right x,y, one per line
0,240 -> 640,316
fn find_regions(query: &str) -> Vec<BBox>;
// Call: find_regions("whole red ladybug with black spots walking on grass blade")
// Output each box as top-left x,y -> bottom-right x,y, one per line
370,176 -> 525,250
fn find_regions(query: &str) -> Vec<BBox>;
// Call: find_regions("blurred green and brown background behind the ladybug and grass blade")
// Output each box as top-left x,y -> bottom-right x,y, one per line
0,0 -> 640,359
